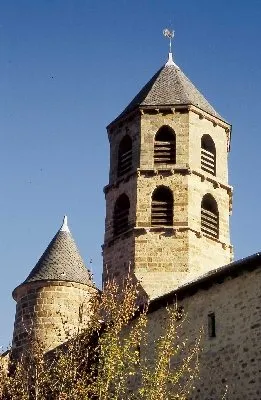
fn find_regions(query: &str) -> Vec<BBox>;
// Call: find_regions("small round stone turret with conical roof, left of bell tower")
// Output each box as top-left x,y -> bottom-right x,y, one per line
12,217 -> 97,357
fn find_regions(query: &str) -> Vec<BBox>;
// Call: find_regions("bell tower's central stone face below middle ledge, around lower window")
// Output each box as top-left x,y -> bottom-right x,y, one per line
134,170 -> 189,298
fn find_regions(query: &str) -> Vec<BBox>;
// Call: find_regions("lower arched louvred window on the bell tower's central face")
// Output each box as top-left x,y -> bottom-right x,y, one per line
151,186 -> 173,226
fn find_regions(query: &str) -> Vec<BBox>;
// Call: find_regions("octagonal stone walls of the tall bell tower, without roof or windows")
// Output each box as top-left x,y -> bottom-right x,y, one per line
104,106 -> 233,298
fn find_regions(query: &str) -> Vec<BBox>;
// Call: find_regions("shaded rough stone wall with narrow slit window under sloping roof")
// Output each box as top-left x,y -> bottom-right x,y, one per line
145,268 -> 261,400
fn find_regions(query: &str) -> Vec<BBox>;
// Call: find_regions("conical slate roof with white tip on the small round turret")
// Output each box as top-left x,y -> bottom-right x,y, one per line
23,217 -> 93,286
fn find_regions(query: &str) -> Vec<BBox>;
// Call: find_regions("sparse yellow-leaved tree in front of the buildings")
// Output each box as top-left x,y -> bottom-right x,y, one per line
0,279 -> 201,400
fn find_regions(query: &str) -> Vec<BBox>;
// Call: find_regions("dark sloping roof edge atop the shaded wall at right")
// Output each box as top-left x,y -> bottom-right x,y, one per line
148,253 -> 261,313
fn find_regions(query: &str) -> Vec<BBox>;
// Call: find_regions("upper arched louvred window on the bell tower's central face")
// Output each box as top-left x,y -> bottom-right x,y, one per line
154,125 -> 176,164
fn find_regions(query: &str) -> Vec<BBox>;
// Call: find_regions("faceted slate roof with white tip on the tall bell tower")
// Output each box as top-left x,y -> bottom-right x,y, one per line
112,53 -> 224,120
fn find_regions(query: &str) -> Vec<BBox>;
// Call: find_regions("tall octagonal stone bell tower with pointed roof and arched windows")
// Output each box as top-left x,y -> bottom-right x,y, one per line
103,48 -> 233,298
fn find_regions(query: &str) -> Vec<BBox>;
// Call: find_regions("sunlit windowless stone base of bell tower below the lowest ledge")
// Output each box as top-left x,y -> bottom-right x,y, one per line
134,229 -> 232,298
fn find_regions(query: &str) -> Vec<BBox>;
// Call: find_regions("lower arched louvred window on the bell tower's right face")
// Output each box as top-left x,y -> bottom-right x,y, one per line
201,193 -> 219,239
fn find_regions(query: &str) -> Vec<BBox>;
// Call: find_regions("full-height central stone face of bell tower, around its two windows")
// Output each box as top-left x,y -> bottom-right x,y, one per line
131,110 -> 189,298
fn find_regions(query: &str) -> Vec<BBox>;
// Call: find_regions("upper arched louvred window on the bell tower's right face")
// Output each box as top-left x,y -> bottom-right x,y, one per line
201,135 -> 216,175
